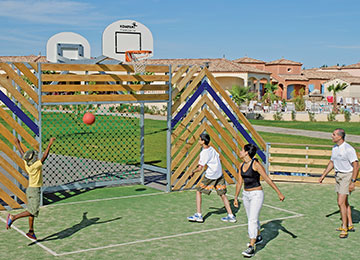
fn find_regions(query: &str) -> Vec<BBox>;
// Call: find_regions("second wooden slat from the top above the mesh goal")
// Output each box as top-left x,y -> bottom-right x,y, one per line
41,74 -> 169,82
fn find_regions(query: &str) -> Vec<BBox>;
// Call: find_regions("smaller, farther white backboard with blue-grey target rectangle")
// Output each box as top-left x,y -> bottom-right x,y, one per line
46,32 -> 91,63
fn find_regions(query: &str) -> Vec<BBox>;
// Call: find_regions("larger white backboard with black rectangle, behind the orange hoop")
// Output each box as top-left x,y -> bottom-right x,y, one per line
102,20 -> 154,62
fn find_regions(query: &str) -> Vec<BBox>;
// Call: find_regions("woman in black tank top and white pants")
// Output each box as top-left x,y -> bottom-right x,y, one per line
234,144 -> 285,257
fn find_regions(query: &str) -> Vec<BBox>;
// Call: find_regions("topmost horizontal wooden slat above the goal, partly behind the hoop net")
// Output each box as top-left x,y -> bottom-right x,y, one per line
41,64 -> 169,73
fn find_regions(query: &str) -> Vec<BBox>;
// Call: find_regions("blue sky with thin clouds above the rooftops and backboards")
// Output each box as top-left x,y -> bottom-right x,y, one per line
0,0 -> 360,68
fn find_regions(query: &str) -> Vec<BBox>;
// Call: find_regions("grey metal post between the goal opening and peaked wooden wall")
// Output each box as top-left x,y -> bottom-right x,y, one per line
166,65 -> 172,192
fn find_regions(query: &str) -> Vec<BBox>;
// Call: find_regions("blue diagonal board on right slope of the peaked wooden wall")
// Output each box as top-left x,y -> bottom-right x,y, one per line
203,81 -> 266,162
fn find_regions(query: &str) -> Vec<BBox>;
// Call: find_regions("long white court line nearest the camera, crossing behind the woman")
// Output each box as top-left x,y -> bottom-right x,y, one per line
54,215 -> 301,256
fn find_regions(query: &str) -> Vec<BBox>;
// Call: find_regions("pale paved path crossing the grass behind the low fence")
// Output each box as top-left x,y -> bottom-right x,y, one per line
253,125 -> 360,143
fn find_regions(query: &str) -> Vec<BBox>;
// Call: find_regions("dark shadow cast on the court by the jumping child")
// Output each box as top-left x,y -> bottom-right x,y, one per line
29,212 -> 122,246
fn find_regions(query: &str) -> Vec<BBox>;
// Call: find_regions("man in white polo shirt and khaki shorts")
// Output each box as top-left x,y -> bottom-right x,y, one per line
319,128 -> 359,238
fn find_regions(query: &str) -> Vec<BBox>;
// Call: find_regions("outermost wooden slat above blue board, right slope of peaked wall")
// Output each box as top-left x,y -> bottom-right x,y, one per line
204,68 -> 266,150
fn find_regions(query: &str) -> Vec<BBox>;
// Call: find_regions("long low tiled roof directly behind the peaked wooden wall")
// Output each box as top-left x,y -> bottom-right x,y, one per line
147,58 -> 271,74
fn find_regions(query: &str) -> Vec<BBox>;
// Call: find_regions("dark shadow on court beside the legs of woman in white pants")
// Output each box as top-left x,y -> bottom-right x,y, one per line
256,220 -> 297,251
